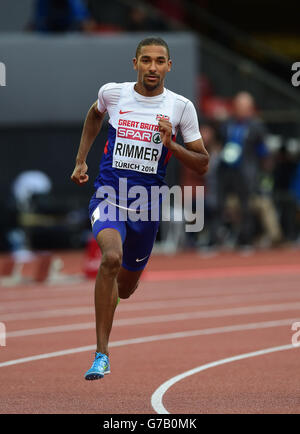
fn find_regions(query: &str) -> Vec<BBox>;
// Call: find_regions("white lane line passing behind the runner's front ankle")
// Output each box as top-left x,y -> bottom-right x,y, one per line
0,319 -> 294,368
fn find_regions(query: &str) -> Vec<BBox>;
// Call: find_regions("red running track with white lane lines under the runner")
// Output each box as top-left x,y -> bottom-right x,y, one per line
0,249 -> 300,414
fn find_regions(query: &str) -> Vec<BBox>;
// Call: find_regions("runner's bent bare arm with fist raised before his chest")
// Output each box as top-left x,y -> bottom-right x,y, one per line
158,120 -> 209,175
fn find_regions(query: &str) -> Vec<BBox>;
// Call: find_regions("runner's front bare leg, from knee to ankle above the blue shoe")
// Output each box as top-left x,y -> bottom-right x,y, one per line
95,228 -> 123,355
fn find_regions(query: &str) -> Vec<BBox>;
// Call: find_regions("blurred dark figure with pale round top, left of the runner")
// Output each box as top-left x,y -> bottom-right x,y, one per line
6,170 -> 90,253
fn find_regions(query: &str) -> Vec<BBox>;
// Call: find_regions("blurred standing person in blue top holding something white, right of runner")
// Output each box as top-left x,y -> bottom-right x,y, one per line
217,92 -> 268,246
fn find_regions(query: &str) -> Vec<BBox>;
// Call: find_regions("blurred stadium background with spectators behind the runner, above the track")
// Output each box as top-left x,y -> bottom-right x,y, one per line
0,0 -> 300,278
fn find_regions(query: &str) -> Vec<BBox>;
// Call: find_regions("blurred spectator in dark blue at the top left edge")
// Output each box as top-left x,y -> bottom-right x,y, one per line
30,0 -> 92,32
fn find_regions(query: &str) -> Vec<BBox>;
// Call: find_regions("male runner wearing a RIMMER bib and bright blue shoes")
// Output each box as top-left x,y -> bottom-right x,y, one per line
71,38 -> 209,380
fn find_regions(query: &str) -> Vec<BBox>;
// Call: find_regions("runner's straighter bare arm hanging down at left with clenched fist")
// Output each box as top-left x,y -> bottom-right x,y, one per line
71,101 -> 105,185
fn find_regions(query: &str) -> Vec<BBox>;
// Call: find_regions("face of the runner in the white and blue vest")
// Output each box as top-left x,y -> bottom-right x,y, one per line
133,45 -> 172,94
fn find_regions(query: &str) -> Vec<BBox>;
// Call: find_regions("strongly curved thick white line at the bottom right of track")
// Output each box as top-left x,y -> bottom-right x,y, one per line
151,344 -> 296,414
